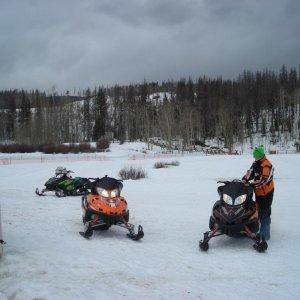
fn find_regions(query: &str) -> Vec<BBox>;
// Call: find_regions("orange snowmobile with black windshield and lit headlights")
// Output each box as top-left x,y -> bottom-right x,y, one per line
79,175 -> 144,241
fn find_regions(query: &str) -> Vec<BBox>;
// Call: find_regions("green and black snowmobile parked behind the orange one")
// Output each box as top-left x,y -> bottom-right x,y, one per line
35,167 -> 91,197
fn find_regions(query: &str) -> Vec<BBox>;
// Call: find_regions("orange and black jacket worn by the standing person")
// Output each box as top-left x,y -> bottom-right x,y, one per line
243,156 -> 274,196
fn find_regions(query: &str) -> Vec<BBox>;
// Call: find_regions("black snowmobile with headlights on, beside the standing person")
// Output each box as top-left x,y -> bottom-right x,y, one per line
199,180 -> 268,252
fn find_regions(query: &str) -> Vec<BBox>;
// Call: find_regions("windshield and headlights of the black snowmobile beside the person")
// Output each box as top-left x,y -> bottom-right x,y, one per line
222,181 -> 252,206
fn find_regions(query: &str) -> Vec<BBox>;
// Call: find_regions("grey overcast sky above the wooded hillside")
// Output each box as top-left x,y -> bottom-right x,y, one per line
0,0 -> 300,91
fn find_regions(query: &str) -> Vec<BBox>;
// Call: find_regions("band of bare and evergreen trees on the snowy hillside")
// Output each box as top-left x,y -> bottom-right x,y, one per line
0,66 -> 300,149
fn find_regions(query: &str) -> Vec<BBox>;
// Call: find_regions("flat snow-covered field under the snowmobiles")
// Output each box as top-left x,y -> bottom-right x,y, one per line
0,144 -> 300,299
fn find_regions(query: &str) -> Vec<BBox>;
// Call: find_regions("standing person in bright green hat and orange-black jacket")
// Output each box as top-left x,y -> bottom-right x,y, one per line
243,146 -> 274,240
